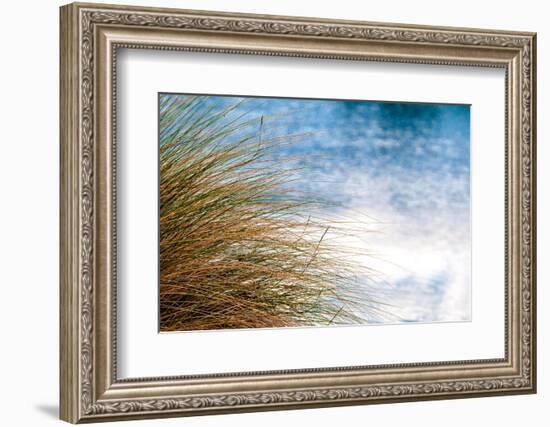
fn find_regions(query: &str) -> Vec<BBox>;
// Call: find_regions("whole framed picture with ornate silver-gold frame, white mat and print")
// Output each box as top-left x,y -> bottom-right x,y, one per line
60,4 -> 536,423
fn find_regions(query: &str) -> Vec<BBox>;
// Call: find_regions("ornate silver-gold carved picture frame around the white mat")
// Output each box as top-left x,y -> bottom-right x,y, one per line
60,4 -> 536,423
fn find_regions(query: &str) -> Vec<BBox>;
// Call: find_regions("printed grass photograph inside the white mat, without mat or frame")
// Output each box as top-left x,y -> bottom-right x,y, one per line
158,93 -> 471,332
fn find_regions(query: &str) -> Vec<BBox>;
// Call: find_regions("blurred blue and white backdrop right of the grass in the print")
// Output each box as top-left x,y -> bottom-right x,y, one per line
162,96 -> 471,323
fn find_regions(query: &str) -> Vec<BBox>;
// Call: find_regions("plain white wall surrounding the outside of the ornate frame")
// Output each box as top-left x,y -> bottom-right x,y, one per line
0,0 -> 550,426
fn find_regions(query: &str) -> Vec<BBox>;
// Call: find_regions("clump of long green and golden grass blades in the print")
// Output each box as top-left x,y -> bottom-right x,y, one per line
160,95 -> 384,331
